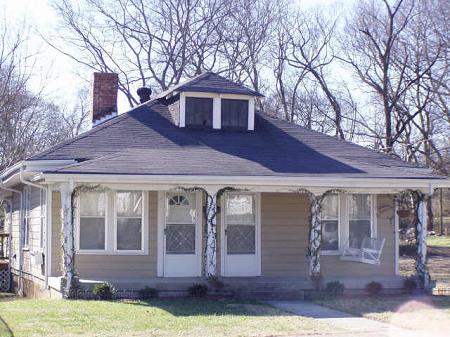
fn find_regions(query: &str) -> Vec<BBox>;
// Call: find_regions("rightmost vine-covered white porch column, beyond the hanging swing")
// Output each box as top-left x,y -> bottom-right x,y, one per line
416,195 -> 430,289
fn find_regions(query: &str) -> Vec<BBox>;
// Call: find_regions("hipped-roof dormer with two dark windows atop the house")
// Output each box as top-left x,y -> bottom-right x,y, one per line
158,72 -> 263,130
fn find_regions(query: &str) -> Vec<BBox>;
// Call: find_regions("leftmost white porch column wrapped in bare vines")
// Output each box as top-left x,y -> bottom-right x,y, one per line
60,182 -> 75,298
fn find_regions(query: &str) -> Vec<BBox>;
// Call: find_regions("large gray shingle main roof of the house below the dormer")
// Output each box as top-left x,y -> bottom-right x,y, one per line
30,100 -> 438,178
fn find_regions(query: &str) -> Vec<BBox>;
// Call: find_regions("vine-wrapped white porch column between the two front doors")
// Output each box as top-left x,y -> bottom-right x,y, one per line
205,189 -> 217,277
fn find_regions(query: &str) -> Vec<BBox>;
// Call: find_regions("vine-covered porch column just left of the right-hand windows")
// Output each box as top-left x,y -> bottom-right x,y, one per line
308,193 -> 322,278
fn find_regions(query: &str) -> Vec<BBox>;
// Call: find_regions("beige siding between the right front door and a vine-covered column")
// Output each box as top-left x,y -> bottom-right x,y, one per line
261,193 -> 309,277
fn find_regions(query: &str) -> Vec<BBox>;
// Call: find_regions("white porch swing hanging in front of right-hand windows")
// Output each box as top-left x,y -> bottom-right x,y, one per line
341,237 -> 386,264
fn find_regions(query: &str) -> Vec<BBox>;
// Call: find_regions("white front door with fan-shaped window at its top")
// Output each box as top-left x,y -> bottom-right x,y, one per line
163,192 -> 201,277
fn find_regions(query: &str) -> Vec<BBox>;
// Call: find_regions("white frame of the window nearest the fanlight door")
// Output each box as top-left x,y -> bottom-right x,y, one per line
113,190 -> 148,255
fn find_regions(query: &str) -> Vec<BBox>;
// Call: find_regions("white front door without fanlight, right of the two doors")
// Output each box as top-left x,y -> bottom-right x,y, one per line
222,192 -> 261,276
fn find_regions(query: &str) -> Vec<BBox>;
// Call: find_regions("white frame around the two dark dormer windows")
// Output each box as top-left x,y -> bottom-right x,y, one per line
178,91 -> 255,131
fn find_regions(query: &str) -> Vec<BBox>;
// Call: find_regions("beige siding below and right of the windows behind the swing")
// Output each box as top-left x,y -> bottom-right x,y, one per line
321,195 -> 395,277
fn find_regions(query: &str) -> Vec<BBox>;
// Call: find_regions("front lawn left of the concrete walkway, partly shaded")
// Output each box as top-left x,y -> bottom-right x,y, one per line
0,298 -> 335,337
